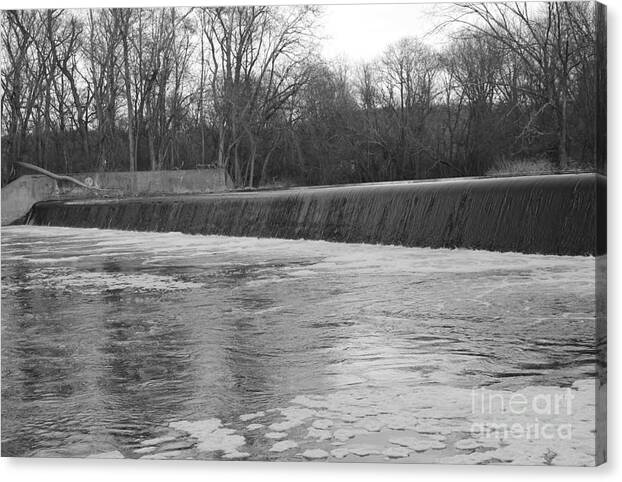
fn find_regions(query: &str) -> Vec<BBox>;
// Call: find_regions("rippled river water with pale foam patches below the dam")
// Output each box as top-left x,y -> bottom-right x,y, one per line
2,226 -> 597,464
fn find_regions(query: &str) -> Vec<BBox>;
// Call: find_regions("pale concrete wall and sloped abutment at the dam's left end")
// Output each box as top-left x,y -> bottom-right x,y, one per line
2,168 -> 231,225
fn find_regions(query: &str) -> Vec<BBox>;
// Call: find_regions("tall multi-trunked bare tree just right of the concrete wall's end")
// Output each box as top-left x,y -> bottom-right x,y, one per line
204,6 -> 316,186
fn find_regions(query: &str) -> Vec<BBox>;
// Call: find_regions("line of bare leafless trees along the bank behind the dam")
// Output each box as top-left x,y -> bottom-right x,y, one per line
1,2 -> 606,187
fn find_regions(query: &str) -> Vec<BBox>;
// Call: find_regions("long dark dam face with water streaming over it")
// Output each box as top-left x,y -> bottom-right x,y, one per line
29,174 -> 606,255
